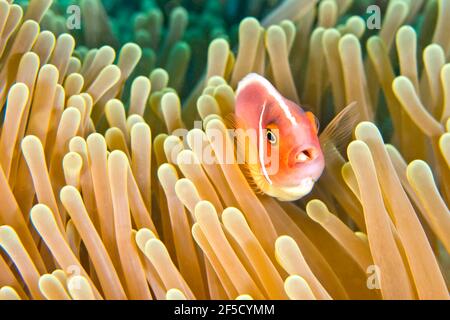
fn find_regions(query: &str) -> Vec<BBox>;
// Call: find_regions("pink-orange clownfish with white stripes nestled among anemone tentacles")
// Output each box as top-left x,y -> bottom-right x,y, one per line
233,73 -> 351,201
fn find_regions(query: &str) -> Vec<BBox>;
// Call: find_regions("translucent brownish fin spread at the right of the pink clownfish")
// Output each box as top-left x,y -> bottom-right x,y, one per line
319,102 -> 359,163
